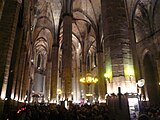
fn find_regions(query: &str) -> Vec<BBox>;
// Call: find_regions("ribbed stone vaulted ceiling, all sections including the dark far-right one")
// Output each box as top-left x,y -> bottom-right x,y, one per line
32,0 -> 160,58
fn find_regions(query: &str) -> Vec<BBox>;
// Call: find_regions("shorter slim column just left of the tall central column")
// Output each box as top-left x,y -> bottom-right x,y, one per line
50,45 -> 59,101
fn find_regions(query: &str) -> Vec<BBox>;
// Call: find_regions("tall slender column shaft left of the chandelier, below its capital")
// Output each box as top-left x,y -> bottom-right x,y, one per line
62,14 -> 72,99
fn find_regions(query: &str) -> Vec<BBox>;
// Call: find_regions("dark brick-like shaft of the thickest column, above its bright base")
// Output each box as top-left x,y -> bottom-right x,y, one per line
102,0 -> 129,76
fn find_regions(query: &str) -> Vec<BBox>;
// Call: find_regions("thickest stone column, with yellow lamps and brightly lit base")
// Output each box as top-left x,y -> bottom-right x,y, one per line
102,0 -> 136,93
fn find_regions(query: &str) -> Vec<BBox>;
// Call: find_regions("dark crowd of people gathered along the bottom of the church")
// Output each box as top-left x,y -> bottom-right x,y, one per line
2,104 -> 160,120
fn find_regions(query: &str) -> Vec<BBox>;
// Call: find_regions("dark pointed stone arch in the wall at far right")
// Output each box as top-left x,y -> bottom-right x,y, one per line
143,51 -> 159,104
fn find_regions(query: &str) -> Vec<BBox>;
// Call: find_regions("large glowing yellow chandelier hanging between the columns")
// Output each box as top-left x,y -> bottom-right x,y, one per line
80,73 -> 98,85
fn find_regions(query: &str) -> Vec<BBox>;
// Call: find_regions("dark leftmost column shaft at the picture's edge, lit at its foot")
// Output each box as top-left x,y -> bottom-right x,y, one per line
0,0 -> 19,97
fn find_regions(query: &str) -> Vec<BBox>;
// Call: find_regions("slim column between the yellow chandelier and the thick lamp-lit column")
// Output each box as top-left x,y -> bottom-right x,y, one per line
97,51 -> 106,102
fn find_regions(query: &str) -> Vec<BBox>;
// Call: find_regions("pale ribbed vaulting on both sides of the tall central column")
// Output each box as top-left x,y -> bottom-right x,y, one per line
32,0 -> 101,58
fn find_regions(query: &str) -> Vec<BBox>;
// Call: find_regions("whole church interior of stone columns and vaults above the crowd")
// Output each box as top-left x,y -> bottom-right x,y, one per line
0,0 -> 160,120
